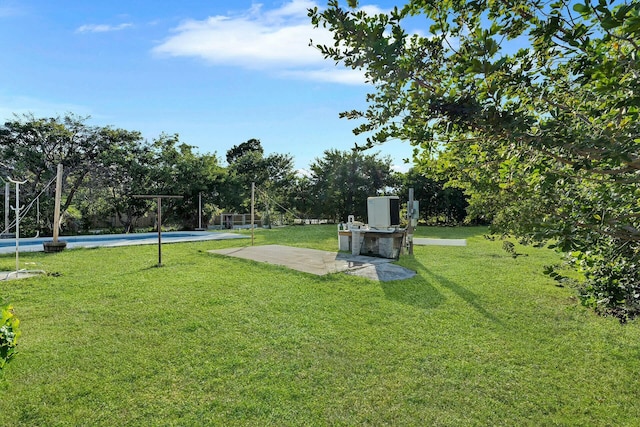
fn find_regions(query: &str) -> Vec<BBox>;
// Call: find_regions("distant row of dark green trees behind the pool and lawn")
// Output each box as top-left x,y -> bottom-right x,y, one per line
0,115 -> 466,234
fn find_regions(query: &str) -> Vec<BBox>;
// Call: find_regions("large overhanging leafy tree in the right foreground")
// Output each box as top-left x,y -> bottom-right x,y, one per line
309,0 -> 640,318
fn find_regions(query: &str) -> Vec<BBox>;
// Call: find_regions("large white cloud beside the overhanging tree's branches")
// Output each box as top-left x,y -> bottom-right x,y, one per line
153,0 -> 380,84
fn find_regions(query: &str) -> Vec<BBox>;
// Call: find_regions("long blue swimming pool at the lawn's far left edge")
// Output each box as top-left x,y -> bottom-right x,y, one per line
0,231 -> 248,254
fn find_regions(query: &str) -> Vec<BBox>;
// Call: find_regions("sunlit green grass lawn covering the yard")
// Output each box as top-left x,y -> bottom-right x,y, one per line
0,226 -> 640,426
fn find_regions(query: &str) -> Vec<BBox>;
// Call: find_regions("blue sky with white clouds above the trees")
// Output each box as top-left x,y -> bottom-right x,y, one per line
0,0 -> 412,171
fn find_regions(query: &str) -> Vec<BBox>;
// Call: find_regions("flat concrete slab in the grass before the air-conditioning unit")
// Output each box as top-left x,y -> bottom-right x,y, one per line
208,245 -> 416,282
